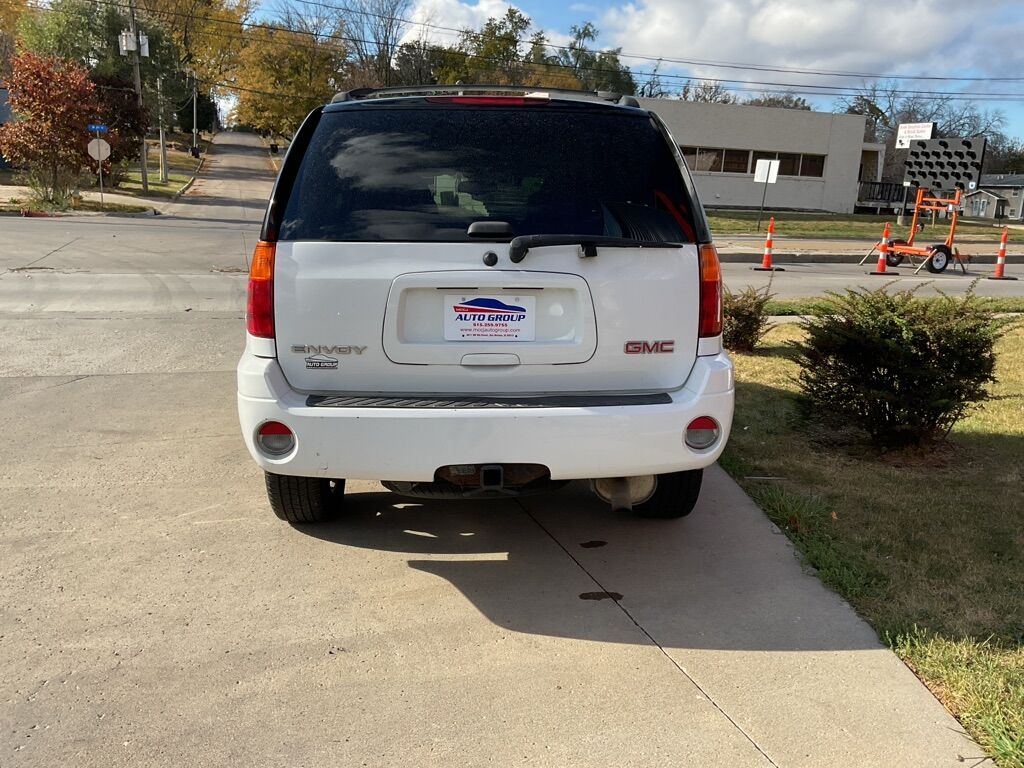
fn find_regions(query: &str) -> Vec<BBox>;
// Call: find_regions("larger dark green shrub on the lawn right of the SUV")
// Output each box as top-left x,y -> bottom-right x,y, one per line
795,287 -> 1006,447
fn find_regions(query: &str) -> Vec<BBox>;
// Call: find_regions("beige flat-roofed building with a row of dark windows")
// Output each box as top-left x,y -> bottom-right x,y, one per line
640,98 -> 884,213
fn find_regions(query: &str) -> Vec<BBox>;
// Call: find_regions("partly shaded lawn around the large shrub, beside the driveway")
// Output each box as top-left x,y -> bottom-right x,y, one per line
722,324 -> 1024,768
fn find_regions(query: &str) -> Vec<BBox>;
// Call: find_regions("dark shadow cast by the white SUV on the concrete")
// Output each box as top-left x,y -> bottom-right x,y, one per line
299,481 -> 880,651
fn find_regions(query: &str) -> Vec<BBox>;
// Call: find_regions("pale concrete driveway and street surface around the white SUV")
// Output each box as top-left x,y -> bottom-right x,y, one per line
0,134 -> 981,768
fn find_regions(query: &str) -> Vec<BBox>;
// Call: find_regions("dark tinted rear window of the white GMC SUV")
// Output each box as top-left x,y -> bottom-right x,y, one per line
279,104 -> 694,242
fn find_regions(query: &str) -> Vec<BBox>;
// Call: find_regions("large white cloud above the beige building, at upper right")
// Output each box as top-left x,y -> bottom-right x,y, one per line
599,0 -> 1024,98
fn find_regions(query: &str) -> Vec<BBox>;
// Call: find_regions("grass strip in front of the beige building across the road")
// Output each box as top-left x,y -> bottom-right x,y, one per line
708,211 -> 1002,243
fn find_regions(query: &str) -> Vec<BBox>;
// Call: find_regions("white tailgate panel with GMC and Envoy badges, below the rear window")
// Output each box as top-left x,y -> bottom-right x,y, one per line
274,242 -> 698,395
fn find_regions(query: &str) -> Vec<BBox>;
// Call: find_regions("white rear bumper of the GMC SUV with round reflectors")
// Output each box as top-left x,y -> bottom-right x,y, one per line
238,352 -> 733,482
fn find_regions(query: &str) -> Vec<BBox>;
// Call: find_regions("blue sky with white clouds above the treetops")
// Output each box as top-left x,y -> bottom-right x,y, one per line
395,0 -> 1024,137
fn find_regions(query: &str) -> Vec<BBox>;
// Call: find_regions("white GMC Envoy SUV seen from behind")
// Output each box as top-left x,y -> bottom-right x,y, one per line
238,86 -> 733,523
